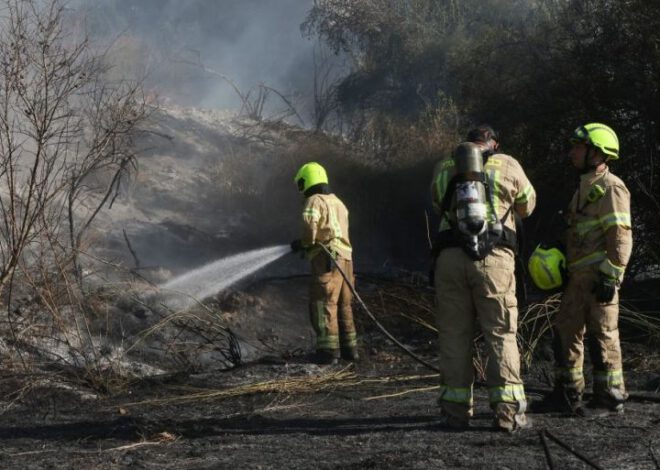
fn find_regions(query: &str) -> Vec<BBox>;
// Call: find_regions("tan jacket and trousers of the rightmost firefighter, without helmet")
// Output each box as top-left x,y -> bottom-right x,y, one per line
554,167 -> 632,401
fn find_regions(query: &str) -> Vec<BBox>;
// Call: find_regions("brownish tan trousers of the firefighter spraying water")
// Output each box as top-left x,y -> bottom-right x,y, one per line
309,253 -> 357,350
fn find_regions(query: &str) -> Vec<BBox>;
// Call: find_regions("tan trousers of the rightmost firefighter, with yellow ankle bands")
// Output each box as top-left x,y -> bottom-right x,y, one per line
554,266 -> 626,399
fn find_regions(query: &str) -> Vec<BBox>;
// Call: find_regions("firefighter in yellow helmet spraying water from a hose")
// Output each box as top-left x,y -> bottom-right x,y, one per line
291,162 -> 358,364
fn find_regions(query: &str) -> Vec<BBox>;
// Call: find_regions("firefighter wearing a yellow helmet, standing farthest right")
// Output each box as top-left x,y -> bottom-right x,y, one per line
532,123 -> 632,415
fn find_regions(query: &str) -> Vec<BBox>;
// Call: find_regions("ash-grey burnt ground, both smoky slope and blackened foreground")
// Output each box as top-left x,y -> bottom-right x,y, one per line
0,107 -> 660,469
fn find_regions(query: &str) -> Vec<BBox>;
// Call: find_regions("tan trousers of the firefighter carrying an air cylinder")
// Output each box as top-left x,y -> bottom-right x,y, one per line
435,248 -> 526,419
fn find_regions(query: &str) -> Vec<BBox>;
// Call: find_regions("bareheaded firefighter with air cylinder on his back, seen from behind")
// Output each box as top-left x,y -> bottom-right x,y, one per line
432,125 -> 536,432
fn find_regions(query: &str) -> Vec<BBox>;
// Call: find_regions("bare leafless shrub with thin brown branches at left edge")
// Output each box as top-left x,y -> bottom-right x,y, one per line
0,0 -> 149,390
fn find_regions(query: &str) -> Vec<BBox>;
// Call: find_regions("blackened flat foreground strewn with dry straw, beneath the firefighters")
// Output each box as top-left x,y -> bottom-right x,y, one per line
0,276 -> 660,469
